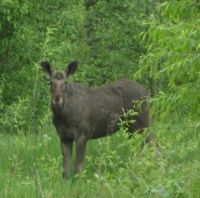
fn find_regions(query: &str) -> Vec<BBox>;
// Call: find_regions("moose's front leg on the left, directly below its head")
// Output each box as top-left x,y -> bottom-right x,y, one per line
61,140 -> 73,179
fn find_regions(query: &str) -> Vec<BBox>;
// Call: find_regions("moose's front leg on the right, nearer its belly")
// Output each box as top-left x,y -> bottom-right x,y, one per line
75,136 -> 87,173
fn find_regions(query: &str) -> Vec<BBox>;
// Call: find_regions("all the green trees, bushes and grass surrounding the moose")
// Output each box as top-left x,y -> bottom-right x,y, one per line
0,0 -> 200,198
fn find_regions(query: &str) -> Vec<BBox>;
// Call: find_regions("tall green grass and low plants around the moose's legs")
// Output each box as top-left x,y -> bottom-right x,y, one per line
0,119 -> 200,198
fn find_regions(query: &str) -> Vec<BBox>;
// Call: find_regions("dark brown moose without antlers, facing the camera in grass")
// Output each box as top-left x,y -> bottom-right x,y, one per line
41,61 -> 149,178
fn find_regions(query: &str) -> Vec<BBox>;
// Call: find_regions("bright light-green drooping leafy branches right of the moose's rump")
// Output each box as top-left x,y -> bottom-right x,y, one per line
136,1 -> 200,119
